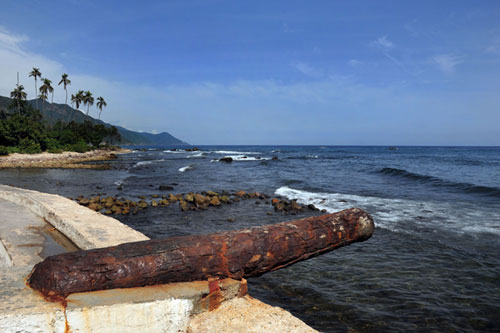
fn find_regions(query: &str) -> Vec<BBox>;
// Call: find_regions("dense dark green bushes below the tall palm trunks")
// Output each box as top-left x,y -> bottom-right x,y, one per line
0,98 -> 120,155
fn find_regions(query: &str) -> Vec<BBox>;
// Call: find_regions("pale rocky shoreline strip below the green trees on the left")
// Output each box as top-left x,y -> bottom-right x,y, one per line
0,148 -> 131,170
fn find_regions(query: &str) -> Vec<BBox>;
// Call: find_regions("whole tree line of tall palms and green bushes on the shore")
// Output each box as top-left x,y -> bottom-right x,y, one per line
0,67 -> 121,155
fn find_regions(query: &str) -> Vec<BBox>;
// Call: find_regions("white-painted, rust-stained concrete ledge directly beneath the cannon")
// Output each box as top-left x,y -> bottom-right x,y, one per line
0,267 -> 246,333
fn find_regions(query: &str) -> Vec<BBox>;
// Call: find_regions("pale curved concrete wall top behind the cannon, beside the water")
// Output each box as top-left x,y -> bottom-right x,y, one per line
0,185 -> 149,250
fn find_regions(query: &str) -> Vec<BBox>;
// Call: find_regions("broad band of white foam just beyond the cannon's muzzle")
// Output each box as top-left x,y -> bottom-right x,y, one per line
275,186 -> 500,235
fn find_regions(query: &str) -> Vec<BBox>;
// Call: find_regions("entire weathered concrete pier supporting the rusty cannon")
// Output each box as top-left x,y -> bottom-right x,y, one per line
0,185 -> 315,333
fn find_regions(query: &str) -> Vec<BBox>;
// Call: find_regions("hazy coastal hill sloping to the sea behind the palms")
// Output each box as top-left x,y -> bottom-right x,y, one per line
0,96 -> 189,146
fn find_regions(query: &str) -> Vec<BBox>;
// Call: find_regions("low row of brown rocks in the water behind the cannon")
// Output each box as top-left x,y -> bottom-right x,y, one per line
75,191 -> 325,215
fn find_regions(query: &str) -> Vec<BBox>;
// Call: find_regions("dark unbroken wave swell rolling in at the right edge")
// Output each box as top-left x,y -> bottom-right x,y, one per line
378,168 -> 500,198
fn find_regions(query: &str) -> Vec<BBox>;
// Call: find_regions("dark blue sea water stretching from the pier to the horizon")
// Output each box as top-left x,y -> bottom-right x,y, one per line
0,146 -> 500,332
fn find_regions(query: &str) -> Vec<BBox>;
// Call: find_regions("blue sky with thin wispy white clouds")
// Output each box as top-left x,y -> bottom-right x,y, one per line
0,0 -> 500,146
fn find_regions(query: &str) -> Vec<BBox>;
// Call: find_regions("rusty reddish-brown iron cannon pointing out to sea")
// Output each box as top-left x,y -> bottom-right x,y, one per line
28,208 -> 374,297
